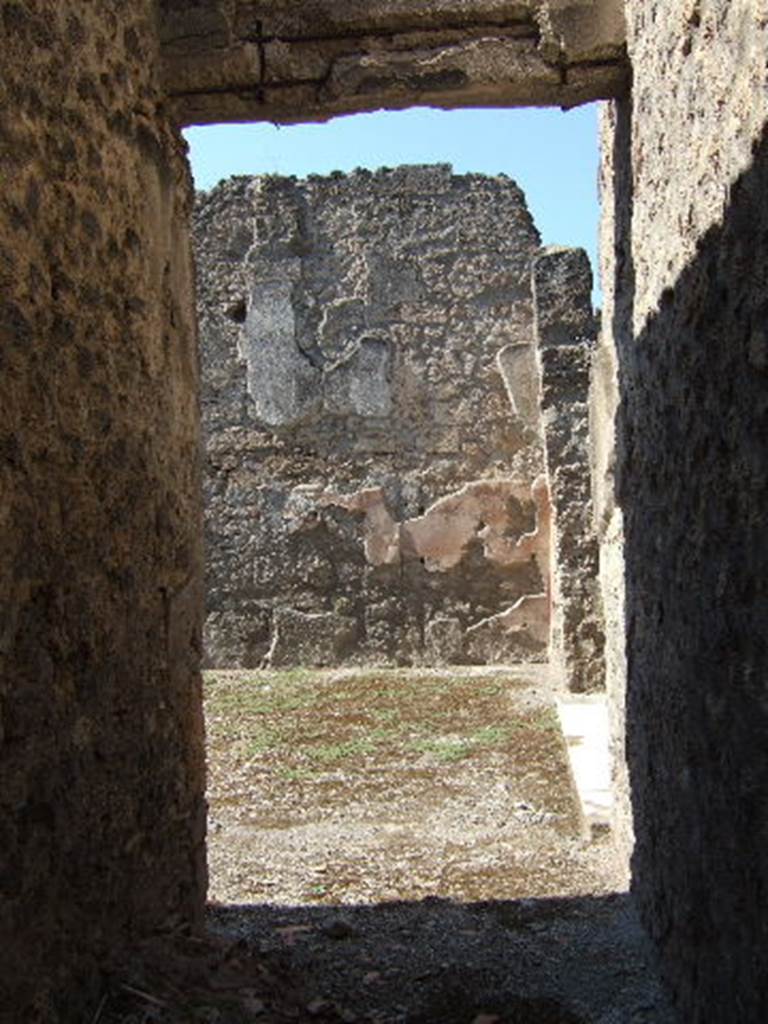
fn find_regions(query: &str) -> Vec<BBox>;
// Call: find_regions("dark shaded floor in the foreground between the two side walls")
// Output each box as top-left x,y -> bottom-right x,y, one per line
96,894 -> 674,1024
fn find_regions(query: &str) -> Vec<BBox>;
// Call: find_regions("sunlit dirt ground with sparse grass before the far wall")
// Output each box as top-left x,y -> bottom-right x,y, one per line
206,666 -> 621,905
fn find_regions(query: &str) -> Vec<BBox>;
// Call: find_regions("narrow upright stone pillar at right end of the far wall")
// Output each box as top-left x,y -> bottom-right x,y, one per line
532,247 -> 605,692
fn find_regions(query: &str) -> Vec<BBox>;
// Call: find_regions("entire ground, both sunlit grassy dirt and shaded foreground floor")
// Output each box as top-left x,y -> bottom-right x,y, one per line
103,666 -> 676,1024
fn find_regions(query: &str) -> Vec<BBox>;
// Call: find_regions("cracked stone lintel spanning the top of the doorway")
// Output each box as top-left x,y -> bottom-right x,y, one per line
159,0 -> 628,124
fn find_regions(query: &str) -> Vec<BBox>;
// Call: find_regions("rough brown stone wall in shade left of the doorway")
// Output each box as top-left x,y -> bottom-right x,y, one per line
0,6 -> 204,1024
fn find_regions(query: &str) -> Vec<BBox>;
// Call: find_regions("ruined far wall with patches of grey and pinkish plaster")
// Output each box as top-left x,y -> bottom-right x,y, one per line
196,166 -> 561,666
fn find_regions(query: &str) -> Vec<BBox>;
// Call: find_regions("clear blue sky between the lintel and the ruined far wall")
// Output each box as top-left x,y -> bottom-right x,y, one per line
184,104 -> 598,303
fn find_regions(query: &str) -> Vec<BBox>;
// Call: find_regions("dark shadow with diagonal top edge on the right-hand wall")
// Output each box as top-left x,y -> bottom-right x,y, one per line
615,110 -> 768,1024
